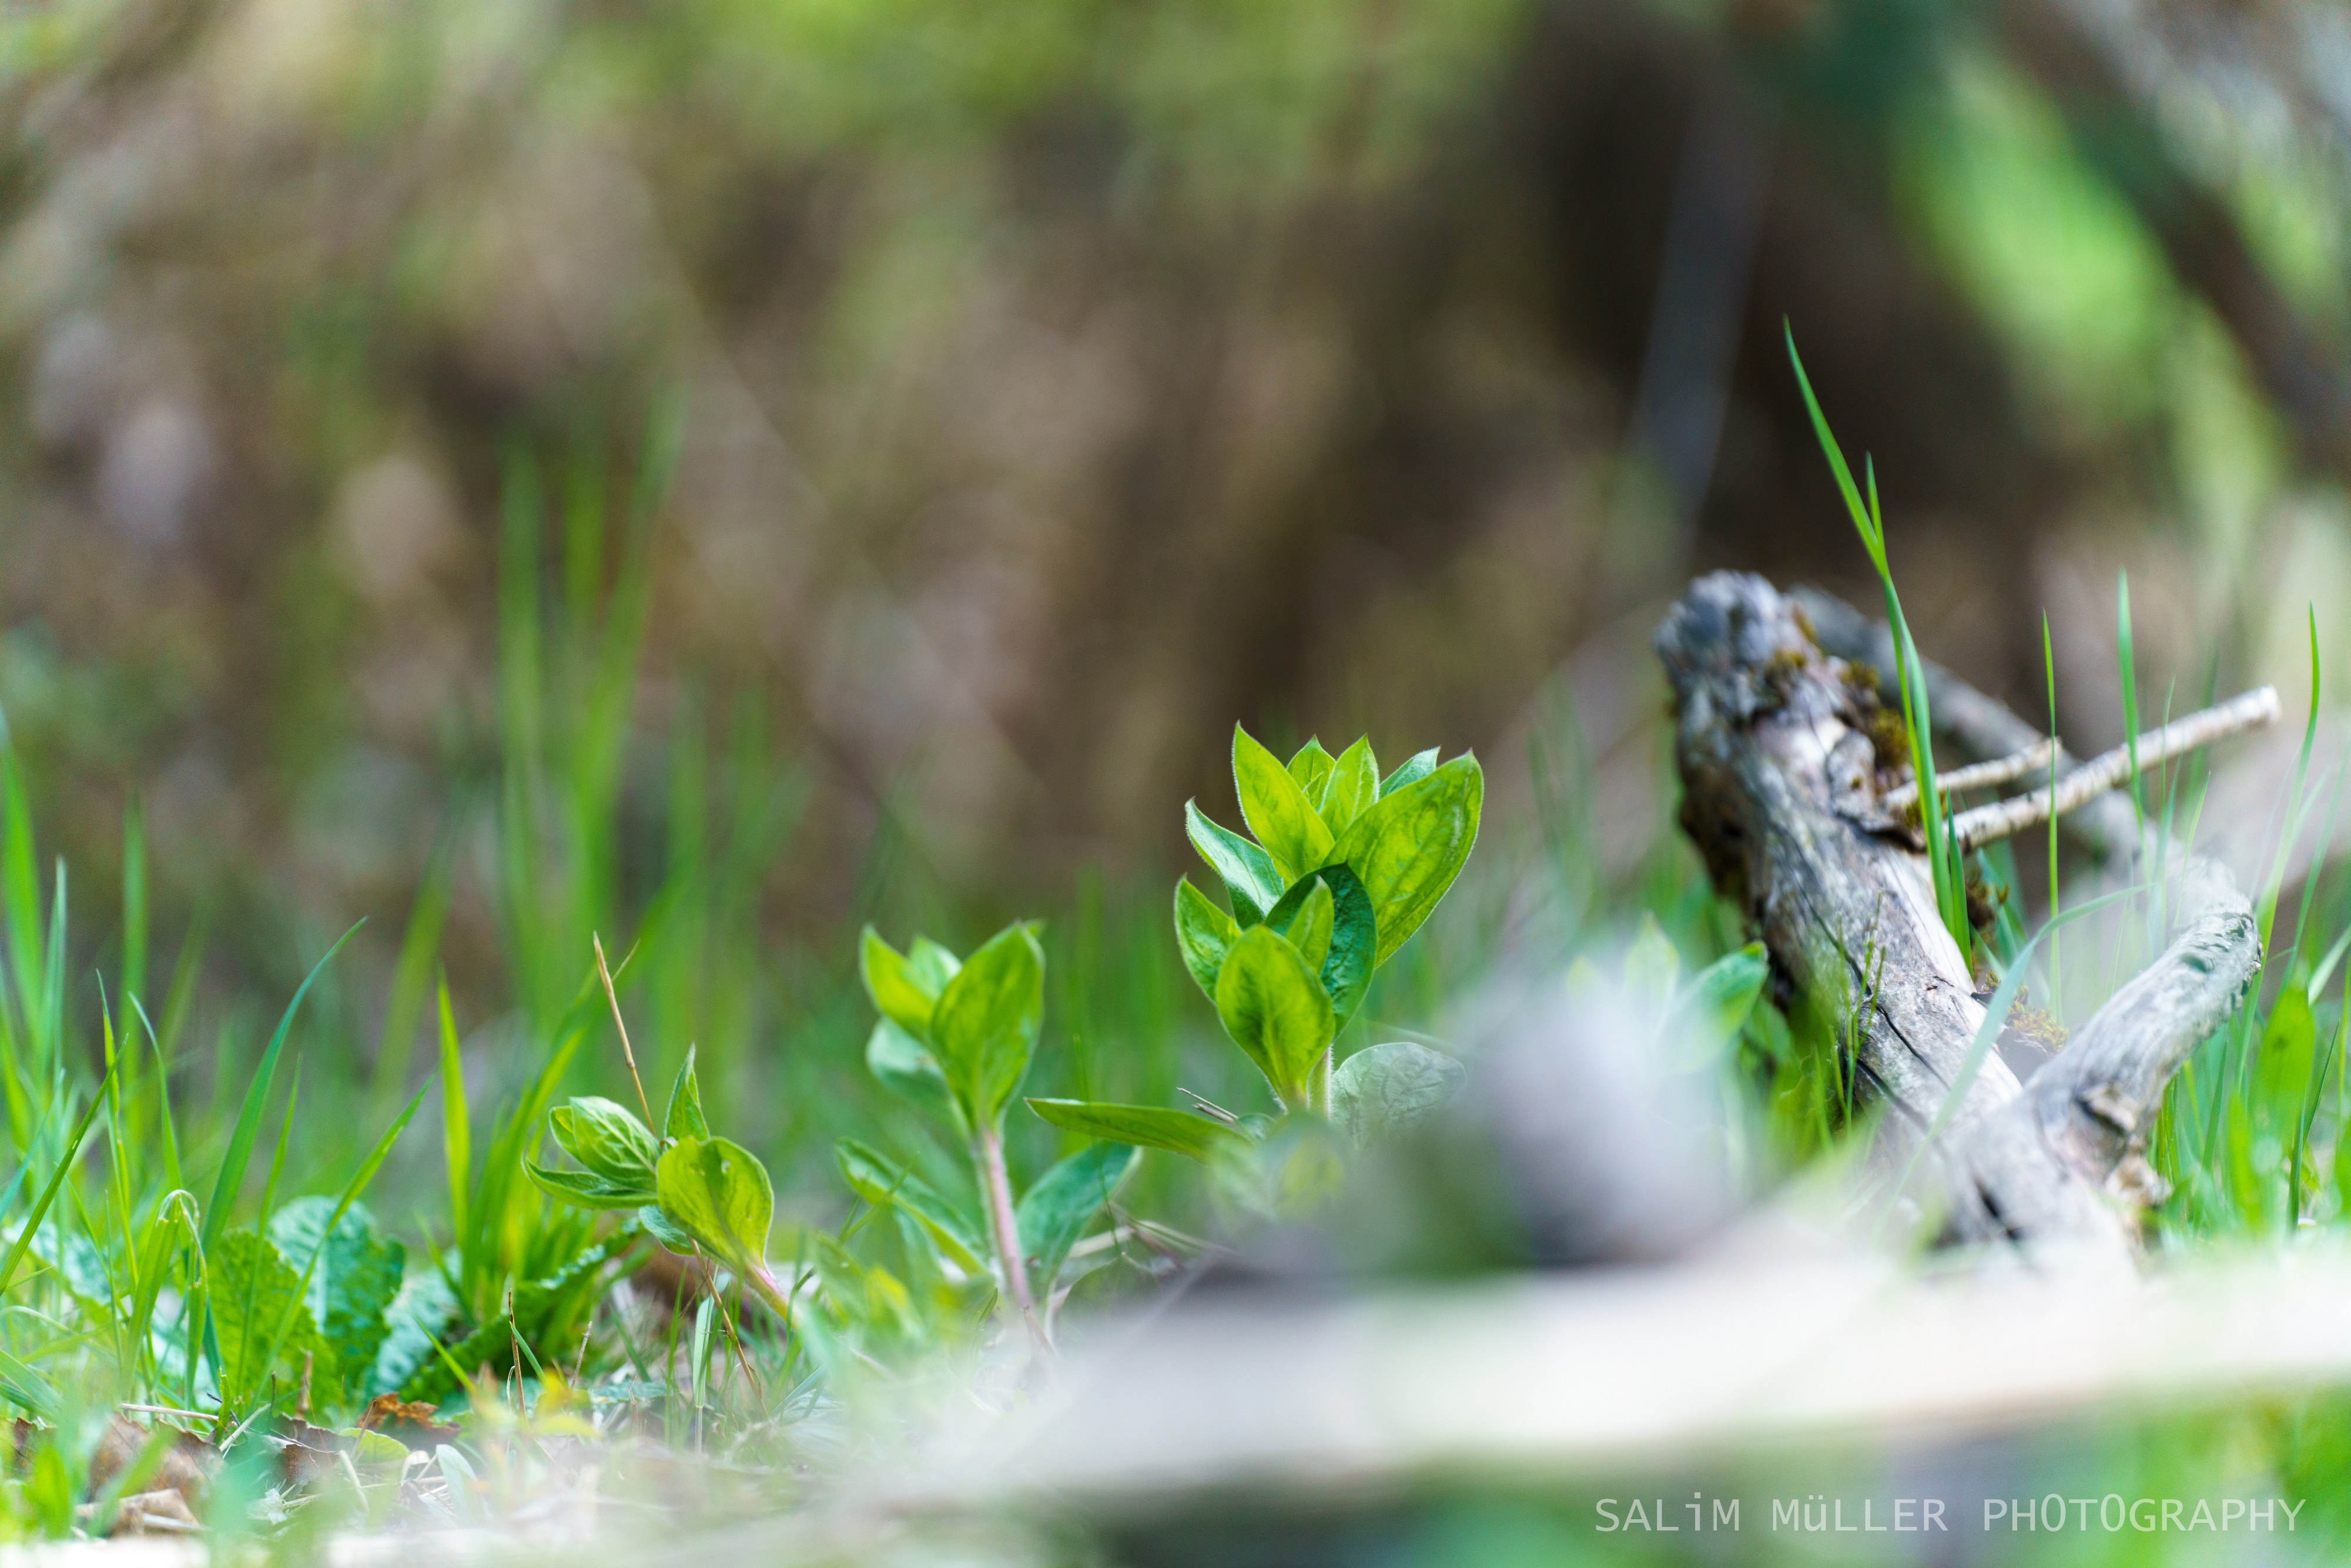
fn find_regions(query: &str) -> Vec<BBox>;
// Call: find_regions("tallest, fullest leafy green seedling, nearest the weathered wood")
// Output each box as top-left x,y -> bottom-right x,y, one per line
1030,726 -> 1486,1161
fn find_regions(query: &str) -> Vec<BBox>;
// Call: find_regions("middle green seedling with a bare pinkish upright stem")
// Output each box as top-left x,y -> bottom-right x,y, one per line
856,922 -> 1136,1342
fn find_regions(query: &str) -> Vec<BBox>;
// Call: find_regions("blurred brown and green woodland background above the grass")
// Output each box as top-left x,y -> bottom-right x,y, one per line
0,0 -> 2351,1011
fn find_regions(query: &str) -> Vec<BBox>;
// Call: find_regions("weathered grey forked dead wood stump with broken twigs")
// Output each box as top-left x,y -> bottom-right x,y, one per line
1655,571 -> 2278,1265
